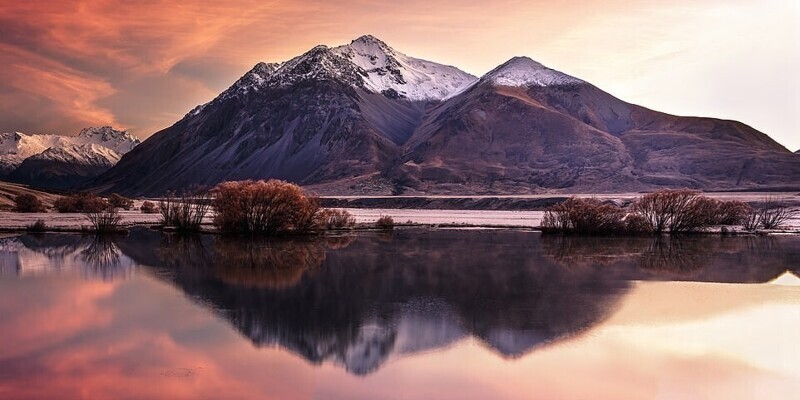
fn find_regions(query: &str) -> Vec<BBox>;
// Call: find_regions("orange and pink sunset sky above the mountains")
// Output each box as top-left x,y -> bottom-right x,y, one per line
0,0 -> 800,151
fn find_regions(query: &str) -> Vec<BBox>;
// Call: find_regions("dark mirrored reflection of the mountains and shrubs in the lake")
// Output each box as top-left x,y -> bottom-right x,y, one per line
0,229 -> 800,375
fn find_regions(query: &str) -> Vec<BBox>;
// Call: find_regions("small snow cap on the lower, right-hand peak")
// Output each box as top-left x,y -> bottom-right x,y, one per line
482,57 -> 584,87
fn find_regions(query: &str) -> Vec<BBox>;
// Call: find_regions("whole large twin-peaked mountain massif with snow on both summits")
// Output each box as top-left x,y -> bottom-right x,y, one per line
91,36 -> 800,195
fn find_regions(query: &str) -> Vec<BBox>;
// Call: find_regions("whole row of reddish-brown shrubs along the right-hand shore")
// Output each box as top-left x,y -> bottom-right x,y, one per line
541,189 -> 795,235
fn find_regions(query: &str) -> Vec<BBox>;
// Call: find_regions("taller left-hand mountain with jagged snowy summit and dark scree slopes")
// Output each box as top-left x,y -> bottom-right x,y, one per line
95,36 -> 476,194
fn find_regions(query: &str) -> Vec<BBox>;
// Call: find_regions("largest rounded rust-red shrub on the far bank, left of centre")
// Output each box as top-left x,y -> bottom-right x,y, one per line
213,180 -> 319,235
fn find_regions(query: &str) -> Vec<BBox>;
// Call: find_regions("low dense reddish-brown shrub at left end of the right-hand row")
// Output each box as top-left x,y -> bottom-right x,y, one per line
542,197 -> 625,235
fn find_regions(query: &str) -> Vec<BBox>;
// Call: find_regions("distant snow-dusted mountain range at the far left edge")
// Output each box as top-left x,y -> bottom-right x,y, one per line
0,126 -> 140,189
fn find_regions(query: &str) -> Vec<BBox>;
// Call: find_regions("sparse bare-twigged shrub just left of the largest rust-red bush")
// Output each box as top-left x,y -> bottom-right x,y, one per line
158,191 -> 211,233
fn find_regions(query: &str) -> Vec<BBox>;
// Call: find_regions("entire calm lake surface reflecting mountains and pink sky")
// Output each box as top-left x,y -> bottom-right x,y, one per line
0,229 -> 800,399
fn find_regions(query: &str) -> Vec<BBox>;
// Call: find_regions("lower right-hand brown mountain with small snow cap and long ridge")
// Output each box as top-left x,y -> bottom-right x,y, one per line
394,58 -> 800,193
